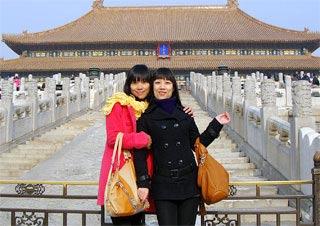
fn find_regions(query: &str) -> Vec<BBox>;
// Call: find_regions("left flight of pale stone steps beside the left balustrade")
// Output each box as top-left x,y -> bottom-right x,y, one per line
0,111 -> 103,180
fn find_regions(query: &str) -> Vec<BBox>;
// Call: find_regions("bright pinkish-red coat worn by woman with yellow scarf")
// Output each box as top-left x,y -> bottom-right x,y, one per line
97,103 -> 150,205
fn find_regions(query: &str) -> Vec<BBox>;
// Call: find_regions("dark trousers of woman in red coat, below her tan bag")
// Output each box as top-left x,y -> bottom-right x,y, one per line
101,206 -> 145,226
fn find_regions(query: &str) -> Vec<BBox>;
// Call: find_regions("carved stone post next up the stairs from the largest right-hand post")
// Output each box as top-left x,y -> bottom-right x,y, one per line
260,79 -> 278,159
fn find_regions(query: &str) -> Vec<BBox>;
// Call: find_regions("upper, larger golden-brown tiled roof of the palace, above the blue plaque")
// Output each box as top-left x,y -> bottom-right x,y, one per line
2,6 -> 320,45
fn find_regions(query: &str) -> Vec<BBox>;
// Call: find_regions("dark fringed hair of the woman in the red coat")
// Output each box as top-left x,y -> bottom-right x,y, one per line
123,64 -> 152,102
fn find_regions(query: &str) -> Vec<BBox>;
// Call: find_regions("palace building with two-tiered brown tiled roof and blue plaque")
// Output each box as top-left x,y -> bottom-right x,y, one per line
0,0 -> 320,77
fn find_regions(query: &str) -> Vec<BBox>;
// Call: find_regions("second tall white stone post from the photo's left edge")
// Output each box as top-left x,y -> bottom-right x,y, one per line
27,80 -> 39,130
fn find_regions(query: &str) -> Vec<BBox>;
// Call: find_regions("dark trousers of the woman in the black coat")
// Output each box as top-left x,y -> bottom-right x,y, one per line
154,197 -> 200,225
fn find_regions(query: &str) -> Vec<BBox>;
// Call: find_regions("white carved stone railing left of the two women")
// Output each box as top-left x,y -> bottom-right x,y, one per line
0,73 -> 126,148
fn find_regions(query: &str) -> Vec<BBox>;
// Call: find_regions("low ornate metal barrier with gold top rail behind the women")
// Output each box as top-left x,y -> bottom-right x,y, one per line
0,180 -> 314,226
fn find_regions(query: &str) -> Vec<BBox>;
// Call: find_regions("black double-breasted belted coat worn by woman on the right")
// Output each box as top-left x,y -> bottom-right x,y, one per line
134,104 -> 222,200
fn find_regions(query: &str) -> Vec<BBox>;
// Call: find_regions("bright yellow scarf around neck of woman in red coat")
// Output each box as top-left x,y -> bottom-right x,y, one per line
102,92 -> 148,119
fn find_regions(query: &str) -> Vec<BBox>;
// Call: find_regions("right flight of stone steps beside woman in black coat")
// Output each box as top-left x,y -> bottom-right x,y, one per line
181,93 -> 296,225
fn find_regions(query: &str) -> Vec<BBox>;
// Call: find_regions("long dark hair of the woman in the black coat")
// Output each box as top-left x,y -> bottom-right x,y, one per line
152,67 -> 182,106
